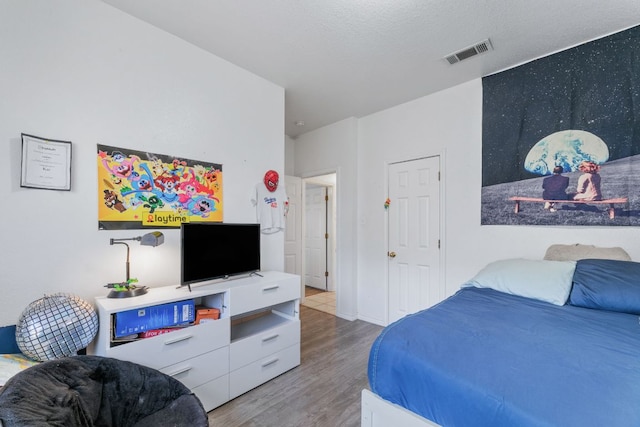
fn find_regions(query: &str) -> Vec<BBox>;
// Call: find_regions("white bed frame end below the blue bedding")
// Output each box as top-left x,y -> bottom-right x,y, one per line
360,389 -> 440,427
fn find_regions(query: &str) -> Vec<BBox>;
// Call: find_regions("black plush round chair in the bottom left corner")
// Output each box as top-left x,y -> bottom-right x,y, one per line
0,356 -> 209,427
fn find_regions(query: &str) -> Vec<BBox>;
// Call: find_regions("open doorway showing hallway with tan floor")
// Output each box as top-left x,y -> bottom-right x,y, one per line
302,173 -> 337,315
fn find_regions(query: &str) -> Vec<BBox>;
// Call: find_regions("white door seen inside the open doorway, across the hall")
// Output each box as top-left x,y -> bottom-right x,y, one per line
304,184 -> 327,290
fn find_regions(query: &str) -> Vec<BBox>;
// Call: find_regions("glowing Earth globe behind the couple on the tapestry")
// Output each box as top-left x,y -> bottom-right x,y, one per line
524,130 -> 609,175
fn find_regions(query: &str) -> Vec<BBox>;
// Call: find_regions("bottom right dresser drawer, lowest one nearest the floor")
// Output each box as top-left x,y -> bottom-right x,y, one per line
229,344 -> 300,399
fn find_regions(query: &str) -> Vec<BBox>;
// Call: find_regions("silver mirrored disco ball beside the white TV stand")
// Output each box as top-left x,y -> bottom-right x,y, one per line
16,293 -> 98,361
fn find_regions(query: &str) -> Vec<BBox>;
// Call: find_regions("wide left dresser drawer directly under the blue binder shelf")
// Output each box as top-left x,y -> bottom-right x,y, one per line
107,317 -> 231,369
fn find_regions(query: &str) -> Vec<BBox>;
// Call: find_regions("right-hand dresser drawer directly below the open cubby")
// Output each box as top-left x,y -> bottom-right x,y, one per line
229,320 -> 300,371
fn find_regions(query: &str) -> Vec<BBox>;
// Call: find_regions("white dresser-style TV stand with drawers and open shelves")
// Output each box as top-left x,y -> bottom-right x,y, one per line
88,271 -> 300,411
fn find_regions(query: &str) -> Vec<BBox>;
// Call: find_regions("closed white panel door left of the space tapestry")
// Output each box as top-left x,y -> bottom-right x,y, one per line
387,156 -> 444,323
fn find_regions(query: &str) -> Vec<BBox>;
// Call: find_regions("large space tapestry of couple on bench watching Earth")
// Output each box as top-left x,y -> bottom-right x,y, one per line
481,26 -> 640,226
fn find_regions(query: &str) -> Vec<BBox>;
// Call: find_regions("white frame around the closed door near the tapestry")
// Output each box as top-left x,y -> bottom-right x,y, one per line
383,149 -> 448,325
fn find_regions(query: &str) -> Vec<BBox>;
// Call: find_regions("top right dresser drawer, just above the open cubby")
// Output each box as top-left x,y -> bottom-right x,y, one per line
230,276 -> 300,316
